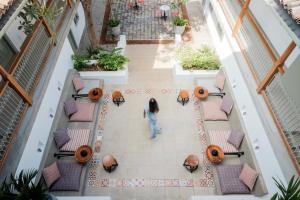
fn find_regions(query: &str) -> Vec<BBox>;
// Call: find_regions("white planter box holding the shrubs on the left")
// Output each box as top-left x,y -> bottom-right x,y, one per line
79,35 -> 128,84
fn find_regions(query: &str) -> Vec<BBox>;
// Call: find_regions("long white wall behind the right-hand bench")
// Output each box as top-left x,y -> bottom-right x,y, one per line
203,0 -> 286,200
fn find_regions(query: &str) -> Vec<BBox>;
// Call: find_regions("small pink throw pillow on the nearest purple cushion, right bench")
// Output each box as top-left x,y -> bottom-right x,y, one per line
239,163 -> 258,191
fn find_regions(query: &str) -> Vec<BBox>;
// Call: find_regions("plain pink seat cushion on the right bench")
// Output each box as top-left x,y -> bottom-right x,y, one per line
203,99 -> 228,121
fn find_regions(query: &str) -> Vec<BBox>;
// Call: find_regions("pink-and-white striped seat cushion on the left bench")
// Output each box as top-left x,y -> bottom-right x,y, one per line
60,129 -> 90,151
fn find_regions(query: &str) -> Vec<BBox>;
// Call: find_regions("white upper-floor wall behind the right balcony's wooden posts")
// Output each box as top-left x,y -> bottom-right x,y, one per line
249,0 -> 300,67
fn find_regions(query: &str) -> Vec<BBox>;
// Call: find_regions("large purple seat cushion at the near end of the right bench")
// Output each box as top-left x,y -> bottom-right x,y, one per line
217,165 -> 250,194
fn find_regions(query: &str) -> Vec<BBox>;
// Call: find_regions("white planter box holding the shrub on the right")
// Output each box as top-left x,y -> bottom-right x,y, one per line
173,60 -> 221,82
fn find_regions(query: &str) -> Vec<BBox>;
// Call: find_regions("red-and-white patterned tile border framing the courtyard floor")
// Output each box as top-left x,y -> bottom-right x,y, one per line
88,88 -> 215,188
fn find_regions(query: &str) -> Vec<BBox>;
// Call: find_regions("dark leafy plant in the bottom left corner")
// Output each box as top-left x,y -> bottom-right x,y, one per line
0,170 -> 49,200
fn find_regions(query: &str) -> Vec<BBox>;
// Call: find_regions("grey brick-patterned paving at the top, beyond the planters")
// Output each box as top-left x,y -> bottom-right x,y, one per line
106,0 -> 180,40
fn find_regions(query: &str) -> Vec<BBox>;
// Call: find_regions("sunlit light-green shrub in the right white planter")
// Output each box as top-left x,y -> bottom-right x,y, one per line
176,46 -> 220,70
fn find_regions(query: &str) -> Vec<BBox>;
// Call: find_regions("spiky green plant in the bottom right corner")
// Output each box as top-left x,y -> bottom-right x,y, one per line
271,176 -> 300,200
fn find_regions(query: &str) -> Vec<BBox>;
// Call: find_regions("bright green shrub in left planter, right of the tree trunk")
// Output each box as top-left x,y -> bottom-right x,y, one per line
97,48 -> 129,71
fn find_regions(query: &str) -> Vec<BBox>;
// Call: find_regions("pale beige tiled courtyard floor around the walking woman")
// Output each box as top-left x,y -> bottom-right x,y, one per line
85,45 -> 215,200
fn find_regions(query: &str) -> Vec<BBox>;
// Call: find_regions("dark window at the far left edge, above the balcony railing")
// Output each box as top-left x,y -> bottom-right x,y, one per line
0,37 -> 16,71
